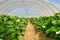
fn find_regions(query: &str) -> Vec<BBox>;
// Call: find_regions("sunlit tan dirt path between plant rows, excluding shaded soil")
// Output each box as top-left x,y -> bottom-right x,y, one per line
24,21 -> 39,40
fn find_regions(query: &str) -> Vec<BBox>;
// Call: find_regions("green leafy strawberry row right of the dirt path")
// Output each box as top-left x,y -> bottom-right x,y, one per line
30,13 -> 60,40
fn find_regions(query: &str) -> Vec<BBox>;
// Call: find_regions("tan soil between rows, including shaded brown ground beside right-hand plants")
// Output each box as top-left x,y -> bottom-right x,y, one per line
19,21 -> 52,40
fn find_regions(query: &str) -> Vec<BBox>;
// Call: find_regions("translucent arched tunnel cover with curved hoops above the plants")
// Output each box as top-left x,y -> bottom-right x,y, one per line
0,0 -> 59,17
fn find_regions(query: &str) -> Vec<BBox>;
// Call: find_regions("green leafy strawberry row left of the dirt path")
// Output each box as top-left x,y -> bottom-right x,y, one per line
0,14 -> 28,40
